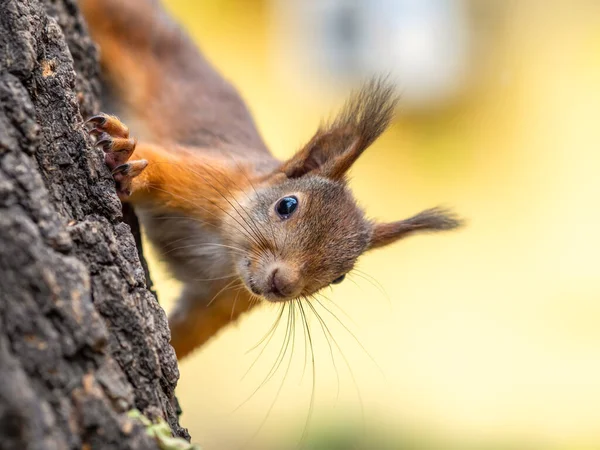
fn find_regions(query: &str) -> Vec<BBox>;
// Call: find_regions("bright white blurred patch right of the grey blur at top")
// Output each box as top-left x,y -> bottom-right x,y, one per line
360,0 -> 469,108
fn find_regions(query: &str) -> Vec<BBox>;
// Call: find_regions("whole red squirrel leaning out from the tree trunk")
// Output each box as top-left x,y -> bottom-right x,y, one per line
79,0 -> 461,359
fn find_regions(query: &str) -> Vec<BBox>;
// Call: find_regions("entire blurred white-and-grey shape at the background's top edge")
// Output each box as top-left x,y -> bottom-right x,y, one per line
275,0 -> 470,109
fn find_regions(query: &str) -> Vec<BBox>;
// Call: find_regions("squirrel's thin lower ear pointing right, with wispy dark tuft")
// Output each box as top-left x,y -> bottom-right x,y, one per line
368,208 -> 463,250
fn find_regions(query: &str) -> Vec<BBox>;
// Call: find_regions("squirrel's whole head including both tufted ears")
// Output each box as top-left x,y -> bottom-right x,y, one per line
223,79 -> 460,301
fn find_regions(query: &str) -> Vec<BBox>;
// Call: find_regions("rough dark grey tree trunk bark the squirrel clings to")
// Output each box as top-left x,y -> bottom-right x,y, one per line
0,0 -> 188,450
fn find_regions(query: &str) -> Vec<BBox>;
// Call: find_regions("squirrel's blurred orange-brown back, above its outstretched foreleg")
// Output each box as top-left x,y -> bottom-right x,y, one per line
79,0 -> 265,149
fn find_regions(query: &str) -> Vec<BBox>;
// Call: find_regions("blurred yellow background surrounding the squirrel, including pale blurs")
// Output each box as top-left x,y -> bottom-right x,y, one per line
144,0 -> 600,450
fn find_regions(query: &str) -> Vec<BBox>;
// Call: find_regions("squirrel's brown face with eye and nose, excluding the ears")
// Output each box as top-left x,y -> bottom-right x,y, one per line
231,175 -> 372,301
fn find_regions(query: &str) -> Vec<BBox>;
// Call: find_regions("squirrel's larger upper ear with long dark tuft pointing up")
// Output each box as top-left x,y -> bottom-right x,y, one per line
280,78 -> 398,179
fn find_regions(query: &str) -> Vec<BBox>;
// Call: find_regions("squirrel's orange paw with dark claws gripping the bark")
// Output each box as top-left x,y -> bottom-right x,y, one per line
86,113 -> 148,199
